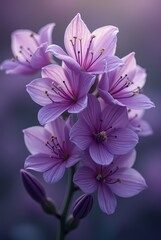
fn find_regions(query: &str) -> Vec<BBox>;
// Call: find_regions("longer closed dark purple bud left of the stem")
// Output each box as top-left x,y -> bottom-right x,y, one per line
20,169 -> 47,204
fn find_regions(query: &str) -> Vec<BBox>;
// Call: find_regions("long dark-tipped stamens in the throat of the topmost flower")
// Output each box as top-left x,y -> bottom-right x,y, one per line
70,35 -> 105,71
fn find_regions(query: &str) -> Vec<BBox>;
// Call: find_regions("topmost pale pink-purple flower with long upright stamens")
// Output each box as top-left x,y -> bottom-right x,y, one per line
47,13 -> 122,73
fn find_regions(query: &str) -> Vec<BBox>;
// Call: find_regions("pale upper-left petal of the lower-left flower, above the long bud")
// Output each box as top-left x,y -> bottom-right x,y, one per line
23,126 -> 51,154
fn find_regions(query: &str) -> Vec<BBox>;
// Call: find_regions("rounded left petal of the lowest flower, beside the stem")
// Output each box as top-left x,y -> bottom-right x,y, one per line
73,167 -> 98,193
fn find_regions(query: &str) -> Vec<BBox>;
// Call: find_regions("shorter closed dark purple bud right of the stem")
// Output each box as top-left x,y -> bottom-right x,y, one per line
73,194 -> 93,219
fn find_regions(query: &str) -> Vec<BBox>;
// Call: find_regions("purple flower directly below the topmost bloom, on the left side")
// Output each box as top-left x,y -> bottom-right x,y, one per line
27,64 -> 95,124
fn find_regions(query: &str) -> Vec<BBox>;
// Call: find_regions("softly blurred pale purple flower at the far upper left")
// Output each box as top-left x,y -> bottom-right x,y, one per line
1,23 -> 55,74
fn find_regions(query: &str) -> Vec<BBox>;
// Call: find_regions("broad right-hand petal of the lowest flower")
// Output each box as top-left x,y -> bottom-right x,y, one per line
108,168 -> 147,197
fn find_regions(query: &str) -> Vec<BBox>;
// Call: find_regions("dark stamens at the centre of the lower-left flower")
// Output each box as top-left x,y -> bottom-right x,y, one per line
45,136 -> 69,161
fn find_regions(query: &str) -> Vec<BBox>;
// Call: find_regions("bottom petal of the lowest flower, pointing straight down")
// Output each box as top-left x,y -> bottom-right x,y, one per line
98,184 -> 117,214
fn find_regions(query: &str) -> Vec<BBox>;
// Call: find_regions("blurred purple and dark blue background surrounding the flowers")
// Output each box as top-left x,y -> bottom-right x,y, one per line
0,0 -> 161,240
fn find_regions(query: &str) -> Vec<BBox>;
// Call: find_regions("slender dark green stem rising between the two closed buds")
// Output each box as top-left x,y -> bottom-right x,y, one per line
57,167 -> 75,240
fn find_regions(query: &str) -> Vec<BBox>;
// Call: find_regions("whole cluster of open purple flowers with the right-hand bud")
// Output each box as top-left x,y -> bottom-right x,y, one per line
1,14 -> 154,218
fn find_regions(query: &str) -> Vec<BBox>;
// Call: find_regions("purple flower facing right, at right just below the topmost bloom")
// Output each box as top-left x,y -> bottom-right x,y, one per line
99,53 -> 154,109
